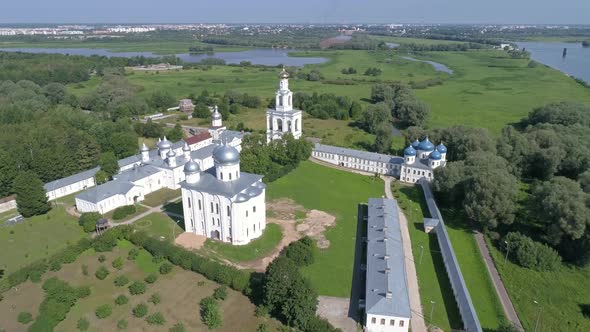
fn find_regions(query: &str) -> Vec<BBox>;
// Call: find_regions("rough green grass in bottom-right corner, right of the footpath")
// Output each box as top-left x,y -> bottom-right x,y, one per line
488,237 -> 590,332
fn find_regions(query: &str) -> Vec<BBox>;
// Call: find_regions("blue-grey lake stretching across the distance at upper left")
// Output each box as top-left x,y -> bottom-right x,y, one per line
0,48 -> 328,67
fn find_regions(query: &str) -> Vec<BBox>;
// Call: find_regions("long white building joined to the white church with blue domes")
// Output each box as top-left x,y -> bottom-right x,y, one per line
311,137 -> 447,183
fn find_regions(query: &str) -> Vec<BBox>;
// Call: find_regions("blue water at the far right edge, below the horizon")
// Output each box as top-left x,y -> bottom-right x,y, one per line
516,42 -> 590,82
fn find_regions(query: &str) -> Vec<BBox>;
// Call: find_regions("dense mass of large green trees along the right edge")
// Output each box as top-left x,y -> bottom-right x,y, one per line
430,103 -> 590,268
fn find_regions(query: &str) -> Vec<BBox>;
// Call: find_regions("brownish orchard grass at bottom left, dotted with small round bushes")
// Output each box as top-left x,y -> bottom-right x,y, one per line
0,243 -> 280,331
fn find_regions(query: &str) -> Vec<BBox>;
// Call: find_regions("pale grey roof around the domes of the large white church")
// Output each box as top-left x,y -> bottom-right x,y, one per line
180,168 -> 262,198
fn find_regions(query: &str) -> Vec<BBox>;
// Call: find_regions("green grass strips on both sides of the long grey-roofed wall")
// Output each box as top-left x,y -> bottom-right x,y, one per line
392,184 -> 504,331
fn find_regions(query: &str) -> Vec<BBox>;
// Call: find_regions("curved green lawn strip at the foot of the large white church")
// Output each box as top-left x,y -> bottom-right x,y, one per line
203,224 -> 283,262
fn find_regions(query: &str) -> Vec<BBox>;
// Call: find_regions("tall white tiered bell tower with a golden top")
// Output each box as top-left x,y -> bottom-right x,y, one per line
266,67 -> 303,142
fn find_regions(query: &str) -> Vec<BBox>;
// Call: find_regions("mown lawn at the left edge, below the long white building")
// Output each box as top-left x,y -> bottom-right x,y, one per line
0,206 -> 86,274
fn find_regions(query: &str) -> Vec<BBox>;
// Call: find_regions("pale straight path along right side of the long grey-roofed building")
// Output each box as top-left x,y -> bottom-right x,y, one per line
382,176 -> 426,332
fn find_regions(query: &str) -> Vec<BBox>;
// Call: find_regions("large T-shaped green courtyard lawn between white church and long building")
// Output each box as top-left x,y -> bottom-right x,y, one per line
266,161 -> 383,297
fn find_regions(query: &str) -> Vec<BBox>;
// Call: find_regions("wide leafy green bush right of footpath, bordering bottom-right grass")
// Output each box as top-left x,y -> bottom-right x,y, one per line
503,232 -> 561,271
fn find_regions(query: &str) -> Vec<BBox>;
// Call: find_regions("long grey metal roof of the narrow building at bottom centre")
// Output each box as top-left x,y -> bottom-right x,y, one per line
365,198 -> 410,318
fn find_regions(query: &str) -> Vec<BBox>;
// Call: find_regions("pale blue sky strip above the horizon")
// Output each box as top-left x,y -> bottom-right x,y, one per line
0,0 -> 590,24
